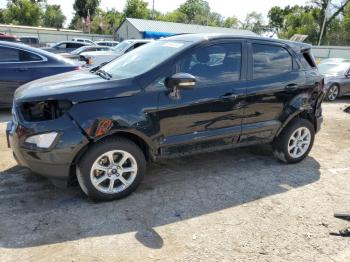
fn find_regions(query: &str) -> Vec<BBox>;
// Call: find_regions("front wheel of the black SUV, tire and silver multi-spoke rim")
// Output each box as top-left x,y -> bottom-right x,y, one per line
77,137 -> 146,200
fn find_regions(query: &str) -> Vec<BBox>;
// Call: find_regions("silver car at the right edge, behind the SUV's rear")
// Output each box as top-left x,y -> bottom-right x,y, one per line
318,59 -> 350,101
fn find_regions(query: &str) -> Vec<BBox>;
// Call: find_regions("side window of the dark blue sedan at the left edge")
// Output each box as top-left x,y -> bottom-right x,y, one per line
0,47 -> 42,63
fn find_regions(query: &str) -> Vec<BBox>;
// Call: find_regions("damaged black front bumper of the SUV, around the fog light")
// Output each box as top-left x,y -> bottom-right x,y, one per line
6,110 -> 89,184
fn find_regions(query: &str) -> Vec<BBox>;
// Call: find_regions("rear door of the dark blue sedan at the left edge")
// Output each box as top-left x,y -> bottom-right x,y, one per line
0,46 -> 44,106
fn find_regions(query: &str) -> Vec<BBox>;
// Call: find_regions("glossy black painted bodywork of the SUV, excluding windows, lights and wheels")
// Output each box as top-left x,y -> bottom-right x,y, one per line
7,36 -> 324,185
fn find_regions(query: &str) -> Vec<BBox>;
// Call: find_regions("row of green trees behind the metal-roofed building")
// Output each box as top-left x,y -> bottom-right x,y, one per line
0,0 -> 350,45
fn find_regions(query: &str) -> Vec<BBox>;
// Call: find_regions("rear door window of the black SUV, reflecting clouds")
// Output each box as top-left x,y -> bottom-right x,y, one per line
253,44 -> 293,79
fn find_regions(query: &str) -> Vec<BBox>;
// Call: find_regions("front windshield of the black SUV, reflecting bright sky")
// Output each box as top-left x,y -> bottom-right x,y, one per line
102,40 -> 191,78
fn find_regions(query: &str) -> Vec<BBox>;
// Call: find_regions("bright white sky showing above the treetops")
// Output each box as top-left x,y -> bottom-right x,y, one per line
0,0 -> 309,24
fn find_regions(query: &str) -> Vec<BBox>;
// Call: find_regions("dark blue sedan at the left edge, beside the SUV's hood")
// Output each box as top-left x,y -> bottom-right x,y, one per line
0,41 -> 78,108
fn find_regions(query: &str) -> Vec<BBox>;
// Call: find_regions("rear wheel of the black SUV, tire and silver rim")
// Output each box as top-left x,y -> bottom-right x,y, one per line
273,118 -> 315,163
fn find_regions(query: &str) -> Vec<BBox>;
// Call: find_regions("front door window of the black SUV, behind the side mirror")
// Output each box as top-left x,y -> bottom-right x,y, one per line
180,43 -> 242,85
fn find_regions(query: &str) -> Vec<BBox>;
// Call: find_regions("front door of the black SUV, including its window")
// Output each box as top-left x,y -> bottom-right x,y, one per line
157,41 -> 246,155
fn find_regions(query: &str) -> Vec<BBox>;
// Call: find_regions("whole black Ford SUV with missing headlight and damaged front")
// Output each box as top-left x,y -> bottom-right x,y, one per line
7,34 -> 324,200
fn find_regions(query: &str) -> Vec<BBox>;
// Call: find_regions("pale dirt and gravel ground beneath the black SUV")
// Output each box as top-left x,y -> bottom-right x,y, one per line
0,99 -> 350,261
